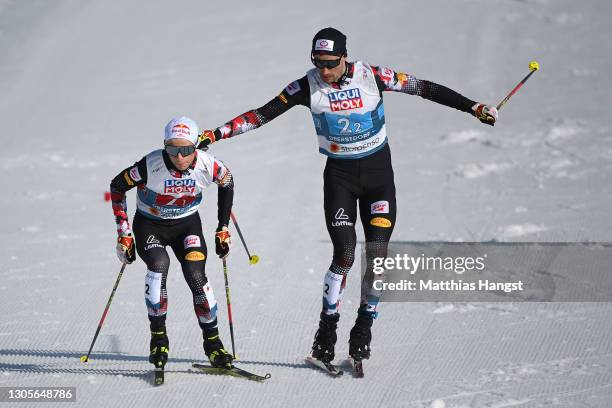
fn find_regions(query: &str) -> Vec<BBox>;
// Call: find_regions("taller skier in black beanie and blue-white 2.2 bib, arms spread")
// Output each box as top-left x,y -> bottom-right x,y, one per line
198,27 -> 498,362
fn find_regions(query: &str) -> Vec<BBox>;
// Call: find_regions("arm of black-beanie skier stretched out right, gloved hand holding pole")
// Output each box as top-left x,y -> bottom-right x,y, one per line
372,66 -> 498,125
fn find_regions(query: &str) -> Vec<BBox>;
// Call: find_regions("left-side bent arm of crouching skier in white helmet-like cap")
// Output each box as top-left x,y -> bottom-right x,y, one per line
110,158 -> 147,263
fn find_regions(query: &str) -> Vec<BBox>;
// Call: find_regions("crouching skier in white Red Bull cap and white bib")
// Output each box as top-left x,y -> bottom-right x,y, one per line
110,117 -> 234,369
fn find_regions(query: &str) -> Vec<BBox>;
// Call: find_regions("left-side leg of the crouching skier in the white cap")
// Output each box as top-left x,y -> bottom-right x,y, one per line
133,215 -> 170,367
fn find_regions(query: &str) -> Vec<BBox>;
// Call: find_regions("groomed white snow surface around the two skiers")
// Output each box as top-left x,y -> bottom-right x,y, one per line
0,0 -> 612,408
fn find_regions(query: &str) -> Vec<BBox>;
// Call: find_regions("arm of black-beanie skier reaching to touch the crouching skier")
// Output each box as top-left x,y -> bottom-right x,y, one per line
198,76 -> 310,149
